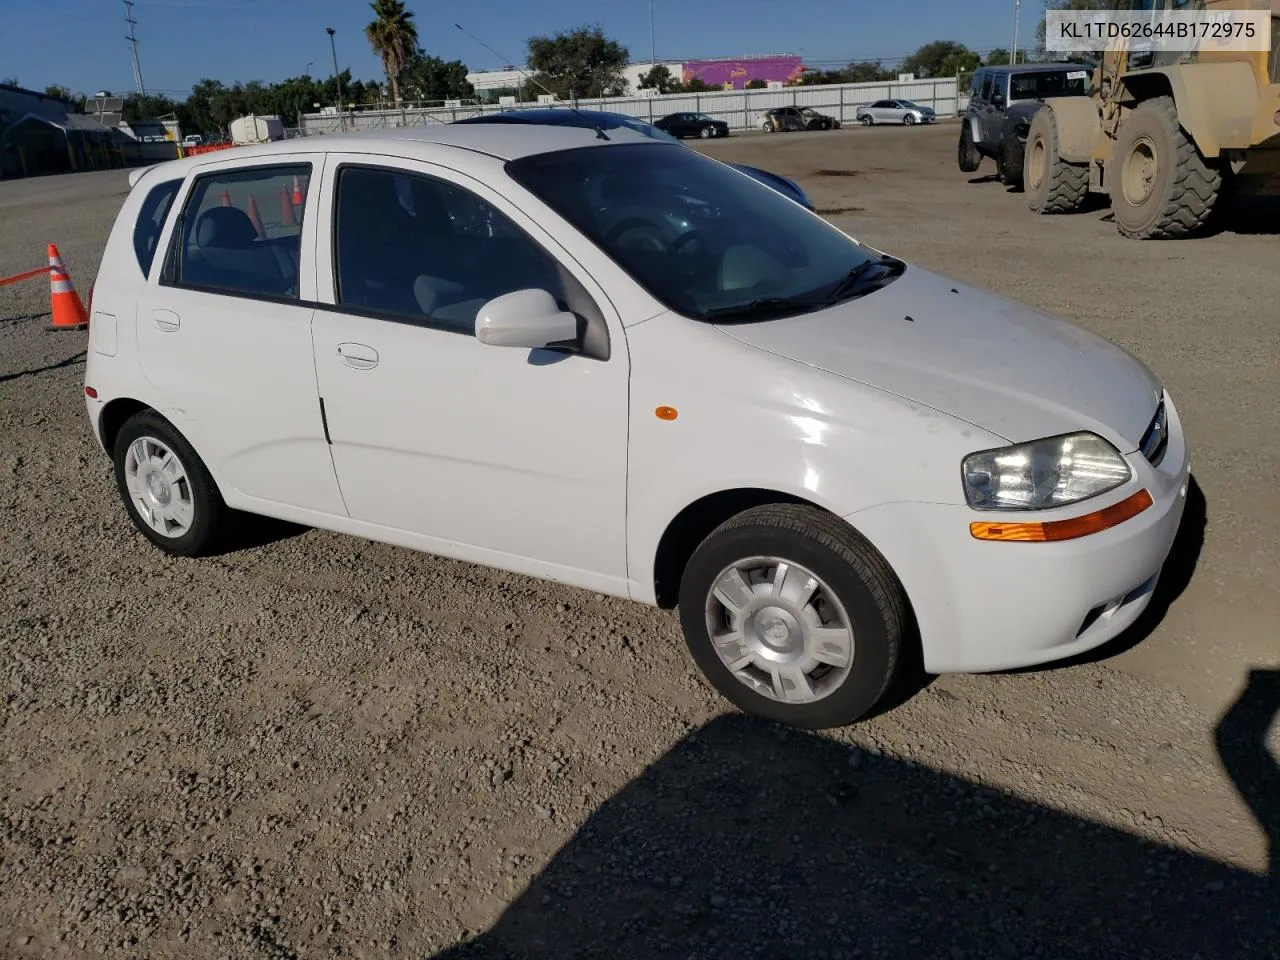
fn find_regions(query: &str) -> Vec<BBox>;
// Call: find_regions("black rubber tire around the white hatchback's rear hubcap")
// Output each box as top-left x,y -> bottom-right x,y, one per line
113,410 -> 233,557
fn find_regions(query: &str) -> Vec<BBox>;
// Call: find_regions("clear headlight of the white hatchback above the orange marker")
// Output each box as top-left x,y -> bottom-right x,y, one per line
964,433 -> 1133,509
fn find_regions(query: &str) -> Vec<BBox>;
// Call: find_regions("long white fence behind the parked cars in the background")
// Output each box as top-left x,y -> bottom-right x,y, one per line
301,77 -> 961,136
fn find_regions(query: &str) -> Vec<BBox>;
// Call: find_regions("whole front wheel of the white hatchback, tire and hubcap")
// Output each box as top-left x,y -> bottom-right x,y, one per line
680,504 -> 906,730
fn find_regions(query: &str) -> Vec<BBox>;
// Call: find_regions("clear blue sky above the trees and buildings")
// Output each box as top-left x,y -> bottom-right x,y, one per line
0,0 -> 1043,96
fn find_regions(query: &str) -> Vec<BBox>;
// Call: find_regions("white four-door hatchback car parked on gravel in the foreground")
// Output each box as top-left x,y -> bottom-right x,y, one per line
84,124 -> 1189,728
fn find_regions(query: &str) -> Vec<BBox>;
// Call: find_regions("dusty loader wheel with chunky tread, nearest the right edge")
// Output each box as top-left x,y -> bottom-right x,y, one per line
1107,96 -> 1222,239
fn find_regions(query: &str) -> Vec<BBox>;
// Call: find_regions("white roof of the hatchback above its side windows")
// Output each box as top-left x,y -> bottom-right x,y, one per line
129,122 -> 663,186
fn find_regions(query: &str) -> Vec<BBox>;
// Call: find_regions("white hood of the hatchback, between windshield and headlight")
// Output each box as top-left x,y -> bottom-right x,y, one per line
721,266 -> 1162,453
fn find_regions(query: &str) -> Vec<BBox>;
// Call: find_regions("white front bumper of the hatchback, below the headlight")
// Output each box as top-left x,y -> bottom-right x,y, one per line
846,397 -> 1190,673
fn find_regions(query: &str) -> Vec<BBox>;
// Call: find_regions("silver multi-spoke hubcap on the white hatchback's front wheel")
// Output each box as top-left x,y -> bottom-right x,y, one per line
707,557 -> 854,704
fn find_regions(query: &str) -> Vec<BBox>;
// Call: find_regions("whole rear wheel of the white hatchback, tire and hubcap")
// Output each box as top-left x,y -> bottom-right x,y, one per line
114,410 -> 230,557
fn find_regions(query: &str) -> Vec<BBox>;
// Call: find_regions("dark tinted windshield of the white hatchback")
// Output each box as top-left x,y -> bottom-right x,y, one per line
507,143 -> 888,320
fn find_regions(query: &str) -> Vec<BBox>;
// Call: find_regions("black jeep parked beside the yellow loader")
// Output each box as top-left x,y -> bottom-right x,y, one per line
956,63 -> 1093,187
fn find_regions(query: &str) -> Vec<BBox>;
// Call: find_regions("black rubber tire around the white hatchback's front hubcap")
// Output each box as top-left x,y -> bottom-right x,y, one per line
680,504 -> 908,730
